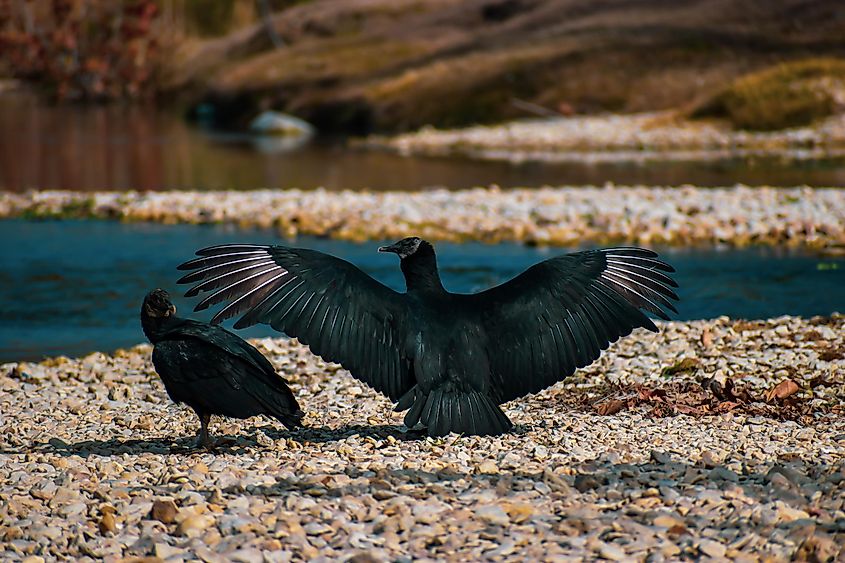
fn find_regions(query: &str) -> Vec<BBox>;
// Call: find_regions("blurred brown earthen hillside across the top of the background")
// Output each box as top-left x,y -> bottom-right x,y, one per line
165,0 -> 845,133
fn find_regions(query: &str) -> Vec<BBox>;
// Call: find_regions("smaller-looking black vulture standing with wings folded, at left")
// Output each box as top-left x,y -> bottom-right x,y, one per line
141,289 -> 303,447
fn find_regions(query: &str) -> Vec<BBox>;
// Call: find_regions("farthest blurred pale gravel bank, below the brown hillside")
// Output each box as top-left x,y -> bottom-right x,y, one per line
370,113 -> 845,160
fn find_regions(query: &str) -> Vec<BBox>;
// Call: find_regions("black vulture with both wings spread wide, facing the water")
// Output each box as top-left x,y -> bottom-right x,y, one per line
179,237 -> 678,436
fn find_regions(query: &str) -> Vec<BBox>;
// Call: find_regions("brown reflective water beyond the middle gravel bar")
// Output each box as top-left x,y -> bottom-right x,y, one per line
0,92 -> 845,191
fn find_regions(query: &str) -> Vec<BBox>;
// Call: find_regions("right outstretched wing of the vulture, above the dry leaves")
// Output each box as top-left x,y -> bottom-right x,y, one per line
466,247 -> 678,403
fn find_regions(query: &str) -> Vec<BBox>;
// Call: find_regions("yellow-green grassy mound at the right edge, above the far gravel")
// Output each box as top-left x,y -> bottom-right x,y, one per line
691,58 -> 845,131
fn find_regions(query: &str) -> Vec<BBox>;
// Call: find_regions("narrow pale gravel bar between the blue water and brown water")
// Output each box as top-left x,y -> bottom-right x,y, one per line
0,185 -> 845,251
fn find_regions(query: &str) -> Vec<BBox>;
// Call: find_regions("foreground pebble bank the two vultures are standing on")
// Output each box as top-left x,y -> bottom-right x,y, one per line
0,316 -> 845,562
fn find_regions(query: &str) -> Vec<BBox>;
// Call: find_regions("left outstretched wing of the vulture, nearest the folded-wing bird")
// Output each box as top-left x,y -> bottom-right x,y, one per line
178,244 -> 413,400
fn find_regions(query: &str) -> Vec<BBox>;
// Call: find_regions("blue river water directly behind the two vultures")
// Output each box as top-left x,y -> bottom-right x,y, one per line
0,220 -> 845,361
